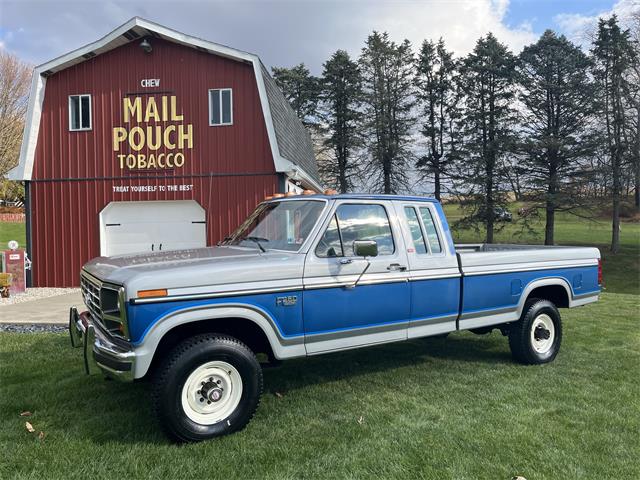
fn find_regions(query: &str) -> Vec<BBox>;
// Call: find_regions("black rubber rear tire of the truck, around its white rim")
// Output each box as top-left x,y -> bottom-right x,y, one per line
509,298 -> 562,365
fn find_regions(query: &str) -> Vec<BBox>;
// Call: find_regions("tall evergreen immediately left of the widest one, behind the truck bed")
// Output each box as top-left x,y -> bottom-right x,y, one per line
456,33 -> 515,243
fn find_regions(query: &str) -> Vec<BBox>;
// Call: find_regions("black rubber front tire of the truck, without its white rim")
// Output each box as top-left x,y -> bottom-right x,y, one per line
152,334 -> 262,442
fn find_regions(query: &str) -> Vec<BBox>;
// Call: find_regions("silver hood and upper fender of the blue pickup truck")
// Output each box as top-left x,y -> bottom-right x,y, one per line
83,246 -> 305,299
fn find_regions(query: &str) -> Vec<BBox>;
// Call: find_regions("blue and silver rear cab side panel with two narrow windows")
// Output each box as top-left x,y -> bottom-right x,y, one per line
395,202 -> 460,338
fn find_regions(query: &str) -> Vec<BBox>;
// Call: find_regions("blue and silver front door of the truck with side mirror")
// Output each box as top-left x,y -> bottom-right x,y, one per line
303,200 -> 410,353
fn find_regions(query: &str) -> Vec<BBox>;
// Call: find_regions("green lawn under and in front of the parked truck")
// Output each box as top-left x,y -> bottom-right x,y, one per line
0,293 -> 640,480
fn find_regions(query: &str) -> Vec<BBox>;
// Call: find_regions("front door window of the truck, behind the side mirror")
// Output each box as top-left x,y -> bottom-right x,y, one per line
316,204 -> 395,257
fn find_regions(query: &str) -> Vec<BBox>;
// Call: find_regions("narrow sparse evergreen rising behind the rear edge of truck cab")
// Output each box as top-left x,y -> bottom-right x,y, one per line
416,38 -> 457,200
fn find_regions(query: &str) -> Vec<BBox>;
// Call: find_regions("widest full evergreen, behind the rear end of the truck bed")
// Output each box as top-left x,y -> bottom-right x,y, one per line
518,30 -> 594,245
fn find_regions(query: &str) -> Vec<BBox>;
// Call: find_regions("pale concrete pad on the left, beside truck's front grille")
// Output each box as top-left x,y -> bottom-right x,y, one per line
0,292 -> 85,325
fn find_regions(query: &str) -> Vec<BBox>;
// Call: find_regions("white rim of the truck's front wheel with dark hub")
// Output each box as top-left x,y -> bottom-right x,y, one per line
181,360 -> 242,425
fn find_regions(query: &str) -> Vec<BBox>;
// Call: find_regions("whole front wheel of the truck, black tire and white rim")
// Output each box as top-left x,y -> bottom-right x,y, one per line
153,334 -> 262,442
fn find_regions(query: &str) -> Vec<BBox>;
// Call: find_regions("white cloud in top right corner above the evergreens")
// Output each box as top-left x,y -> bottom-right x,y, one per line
553,0 -> 640,46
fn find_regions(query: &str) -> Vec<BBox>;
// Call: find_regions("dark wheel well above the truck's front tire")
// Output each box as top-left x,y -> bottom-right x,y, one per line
145,318 -> 275,376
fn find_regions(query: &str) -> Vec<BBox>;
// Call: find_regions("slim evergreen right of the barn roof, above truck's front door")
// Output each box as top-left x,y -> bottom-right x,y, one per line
319,50 -> 362,193
